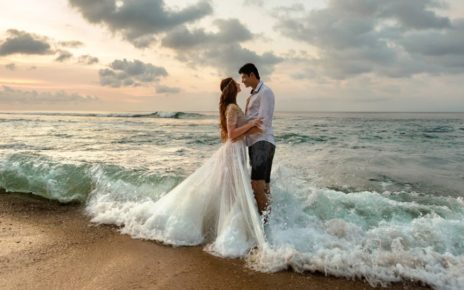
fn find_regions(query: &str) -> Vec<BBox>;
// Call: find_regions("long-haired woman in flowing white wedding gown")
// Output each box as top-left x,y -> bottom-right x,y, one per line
145,78 -> 265,257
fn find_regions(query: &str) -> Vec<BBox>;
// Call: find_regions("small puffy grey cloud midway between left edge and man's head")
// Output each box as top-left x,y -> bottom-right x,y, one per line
99,59 -> 168,88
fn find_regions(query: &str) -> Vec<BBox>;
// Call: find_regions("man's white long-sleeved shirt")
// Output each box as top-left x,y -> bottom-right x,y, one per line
245,81 -> 275,146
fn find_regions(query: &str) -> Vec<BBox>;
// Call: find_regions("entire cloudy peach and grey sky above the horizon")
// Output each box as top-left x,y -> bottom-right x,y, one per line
0,0 -> 464,112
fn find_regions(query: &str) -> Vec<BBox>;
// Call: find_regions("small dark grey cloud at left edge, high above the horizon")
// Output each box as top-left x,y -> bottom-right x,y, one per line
0,29 -> 52,55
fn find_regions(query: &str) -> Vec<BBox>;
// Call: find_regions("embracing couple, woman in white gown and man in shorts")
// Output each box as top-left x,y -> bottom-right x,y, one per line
143,63 -> 275,257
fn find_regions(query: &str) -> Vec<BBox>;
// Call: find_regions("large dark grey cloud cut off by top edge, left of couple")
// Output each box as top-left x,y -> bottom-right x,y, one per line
69,0 -> 213,47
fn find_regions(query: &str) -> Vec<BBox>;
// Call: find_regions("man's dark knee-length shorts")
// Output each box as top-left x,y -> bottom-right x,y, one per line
248,141 -> 275,183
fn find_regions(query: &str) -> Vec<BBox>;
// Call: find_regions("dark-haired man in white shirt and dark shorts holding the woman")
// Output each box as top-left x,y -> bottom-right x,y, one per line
238,63 -> 275,215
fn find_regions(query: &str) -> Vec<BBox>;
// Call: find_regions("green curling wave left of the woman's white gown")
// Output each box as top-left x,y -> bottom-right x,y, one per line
0,153 -> 182,203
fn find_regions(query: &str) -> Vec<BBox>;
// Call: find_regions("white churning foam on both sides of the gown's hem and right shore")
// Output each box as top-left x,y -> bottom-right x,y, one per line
87,165 -> 464,289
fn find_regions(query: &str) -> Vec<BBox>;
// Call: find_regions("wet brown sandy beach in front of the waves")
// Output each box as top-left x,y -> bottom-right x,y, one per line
0,189 -> 430,289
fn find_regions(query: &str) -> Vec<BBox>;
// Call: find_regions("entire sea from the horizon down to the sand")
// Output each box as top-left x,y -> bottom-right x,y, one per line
0,112 -> 464,289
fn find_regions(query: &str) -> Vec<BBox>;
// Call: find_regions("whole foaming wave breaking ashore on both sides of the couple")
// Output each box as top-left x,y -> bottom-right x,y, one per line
0,153 -> 464,289
